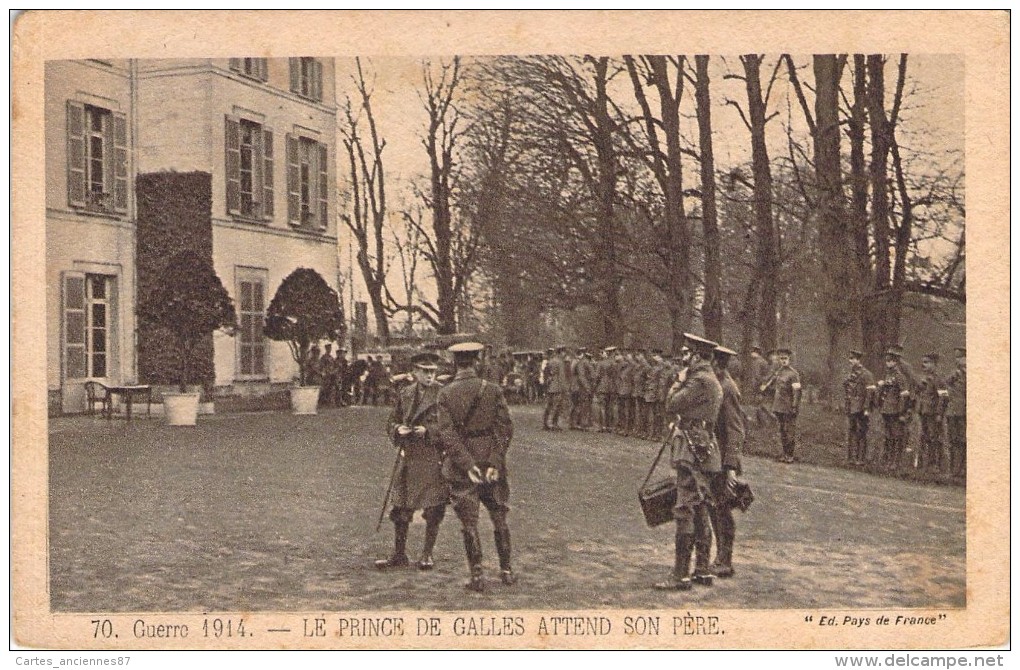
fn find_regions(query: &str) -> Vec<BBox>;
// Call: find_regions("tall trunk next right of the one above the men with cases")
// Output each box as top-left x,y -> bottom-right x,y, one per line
741,55 -> 780,351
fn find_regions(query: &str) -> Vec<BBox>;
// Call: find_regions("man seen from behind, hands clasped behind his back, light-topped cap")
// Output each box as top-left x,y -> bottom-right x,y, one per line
438,343 -> 517,592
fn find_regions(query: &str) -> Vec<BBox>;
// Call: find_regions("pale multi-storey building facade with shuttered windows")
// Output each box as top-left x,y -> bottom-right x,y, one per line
45,57 -> 339,413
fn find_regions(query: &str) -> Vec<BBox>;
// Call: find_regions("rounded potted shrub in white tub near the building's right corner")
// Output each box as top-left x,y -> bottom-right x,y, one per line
264,267 -> 344,414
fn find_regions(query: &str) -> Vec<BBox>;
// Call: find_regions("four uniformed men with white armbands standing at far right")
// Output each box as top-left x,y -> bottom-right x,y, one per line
844,346 -> 967,476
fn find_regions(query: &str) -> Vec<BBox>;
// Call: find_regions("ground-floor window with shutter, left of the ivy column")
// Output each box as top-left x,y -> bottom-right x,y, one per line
63,272 -> 113,379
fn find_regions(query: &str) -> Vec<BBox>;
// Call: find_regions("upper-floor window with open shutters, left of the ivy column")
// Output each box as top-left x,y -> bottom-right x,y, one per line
67,100 -> 128,213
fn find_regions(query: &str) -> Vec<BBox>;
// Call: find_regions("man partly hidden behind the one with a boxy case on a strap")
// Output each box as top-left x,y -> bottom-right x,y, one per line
698,347 -> 747,579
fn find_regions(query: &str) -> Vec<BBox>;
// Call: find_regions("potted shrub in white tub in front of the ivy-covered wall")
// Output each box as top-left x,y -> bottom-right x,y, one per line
139,251 -> 237,425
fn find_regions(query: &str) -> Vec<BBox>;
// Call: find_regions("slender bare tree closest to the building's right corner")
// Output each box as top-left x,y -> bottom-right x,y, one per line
340,58 -> 390,343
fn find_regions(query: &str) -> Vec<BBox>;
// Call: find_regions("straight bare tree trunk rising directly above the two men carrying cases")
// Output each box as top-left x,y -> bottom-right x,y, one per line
695,56 -> 722,343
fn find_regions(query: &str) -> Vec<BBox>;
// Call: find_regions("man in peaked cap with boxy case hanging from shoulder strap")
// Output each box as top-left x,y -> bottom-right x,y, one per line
655,333 -> 722,590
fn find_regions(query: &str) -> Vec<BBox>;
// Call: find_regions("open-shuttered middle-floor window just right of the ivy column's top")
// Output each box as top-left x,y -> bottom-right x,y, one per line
225,116 -> 273,219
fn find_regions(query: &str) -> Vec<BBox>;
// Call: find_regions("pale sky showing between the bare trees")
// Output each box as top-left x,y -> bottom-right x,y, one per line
337,54 -> 965,322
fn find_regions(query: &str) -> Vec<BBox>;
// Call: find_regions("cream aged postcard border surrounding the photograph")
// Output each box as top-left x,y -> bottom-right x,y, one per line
10,11 -> 1010,650
